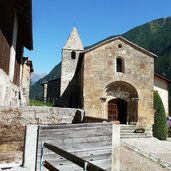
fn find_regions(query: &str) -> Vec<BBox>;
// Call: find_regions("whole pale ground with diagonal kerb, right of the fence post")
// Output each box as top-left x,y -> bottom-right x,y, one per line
121,138 -> 171,171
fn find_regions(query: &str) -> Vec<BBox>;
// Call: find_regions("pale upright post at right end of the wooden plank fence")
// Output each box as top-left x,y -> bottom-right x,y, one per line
111,123 -> 120,171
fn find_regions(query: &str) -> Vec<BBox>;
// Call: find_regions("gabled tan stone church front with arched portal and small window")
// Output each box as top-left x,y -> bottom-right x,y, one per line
83,37 -> 155,124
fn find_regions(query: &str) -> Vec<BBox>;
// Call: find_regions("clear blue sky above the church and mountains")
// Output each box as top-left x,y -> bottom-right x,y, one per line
25,0 -> 171,73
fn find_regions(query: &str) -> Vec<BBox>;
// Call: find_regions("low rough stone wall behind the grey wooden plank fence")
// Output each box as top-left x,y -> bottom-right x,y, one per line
0,107 -> 83,148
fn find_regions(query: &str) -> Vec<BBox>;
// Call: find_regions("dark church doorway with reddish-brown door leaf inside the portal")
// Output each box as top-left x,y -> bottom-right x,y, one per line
108,99 -> 127,124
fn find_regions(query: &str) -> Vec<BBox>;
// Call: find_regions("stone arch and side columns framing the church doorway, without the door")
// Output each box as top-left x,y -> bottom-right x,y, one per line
101,81 -> 139,124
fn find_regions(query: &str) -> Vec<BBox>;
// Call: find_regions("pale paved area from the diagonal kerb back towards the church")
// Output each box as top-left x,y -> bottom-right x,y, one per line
121,138 -> 171,171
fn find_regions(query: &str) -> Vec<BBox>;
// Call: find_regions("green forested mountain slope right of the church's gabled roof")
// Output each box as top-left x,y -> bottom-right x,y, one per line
122,17 -> 171,79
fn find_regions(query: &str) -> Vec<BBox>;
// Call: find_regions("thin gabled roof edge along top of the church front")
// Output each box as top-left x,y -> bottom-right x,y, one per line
83,36 -> 158,57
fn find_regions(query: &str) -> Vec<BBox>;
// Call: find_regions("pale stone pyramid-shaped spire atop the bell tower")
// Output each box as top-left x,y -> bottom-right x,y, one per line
63,27 -> 84,50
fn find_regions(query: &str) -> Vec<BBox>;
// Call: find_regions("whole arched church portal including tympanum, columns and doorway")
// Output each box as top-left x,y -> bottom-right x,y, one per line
105,81 -> 138,124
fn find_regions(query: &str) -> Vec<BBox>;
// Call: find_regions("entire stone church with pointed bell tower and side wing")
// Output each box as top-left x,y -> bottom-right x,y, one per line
42,28 -> 170,126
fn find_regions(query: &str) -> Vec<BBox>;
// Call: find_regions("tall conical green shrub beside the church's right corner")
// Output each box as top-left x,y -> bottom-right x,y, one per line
153,92 -> 168,140
